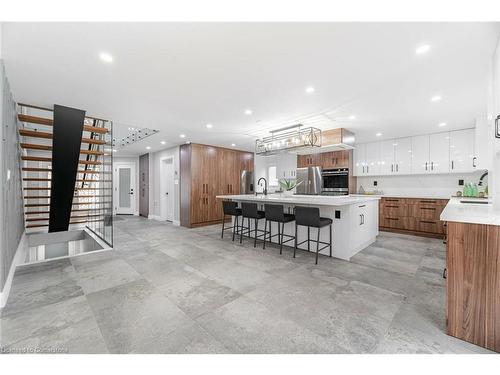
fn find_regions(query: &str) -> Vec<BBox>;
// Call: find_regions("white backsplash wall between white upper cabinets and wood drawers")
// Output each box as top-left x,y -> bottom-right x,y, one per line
357,171 -> 489,198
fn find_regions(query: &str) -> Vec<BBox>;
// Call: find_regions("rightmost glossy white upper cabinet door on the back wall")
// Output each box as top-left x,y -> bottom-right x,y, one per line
450,129 -> 475,173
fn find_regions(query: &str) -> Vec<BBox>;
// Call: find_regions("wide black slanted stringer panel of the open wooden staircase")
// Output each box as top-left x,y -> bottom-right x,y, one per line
49,105 -> 85,232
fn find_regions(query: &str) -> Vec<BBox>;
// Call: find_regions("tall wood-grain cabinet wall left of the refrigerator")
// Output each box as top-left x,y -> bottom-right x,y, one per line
180,144 -> 253,227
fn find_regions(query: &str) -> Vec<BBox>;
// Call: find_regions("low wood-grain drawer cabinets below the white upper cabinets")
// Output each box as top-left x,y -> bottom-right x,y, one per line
379,197 -> 448,238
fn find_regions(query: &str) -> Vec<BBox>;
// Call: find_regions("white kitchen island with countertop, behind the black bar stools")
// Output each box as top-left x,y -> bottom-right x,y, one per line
217,194 -> 380,260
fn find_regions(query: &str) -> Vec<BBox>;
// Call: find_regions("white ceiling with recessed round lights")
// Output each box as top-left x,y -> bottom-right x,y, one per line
3,23 -> 500,155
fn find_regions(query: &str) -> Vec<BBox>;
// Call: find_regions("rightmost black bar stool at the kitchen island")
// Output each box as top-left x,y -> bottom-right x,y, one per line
293,206 -> 333,264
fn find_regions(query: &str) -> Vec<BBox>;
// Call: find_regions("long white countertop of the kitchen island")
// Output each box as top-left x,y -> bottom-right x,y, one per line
217,194 -> 380,206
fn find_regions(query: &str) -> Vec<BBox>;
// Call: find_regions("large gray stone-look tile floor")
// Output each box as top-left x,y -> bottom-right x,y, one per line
0,217 -> 487,353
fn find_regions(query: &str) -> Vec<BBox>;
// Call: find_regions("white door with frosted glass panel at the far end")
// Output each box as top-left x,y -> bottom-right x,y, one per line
113,164 -> 136,215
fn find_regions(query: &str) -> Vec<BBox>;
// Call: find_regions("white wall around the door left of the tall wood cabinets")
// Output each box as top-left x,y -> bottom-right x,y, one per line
149,147 -> 180,224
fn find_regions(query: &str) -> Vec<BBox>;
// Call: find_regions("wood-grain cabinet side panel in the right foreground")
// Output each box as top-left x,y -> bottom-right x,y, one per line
446,222 -> 500,352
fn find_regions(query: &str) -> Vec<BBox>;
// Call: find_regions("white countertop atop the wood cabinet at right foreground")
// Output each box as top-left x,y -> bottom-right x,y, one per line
441,198 -> 500,225
